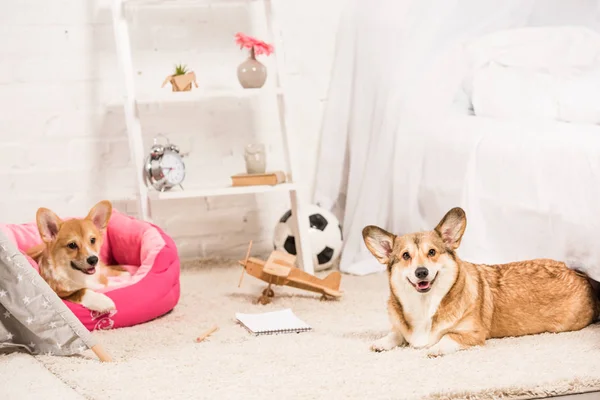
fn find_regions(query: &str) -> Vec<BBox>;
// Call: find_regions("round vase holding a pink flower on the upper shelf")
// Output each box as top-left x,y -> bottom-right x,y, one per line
235,33 -> 273,89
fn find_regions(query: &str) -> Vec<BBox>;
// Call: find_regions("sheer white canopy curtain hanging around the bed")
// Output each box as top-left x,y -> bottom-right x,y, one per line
313,0 -> 600,274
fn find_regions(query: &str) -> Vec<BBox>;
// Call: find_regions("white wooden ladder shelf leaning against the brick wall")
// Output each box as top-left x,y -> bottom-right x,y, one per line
112,0 -> 314,274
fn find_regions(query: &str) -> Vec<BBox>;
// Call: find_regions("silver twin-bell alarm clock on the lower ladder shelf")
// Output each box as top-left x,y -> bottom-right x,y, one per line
144,134 -> 185,192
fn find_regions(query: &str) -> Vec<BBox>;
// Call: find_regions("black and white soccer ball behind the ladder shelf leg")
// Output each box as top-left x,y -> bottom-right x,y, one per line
273,204 -> 343,271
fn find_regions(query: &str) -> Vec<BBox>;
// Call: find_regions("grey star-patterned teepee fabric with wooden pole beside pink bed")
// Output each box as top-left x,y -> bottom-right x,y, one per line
0,227 -> 110,361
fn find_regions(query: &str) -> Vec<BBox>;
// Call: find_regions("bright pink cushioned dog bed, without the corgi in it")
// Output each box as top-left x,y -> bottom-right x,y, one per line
0,210 -> 180,331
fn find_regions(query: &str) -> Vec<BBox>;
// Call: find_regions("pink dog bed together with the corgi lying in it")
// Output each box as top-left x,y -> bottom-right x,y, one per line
0,201 -> 180,330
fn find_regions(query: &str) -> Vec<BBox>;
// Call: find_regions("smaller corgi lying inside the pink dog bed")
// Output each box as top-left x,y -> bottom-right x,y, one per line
27,200 -> 129,312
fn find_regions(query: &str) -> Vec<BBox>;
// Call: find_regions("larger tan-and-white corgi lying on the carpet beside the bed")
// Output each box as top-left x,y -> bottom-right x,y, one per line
363,208 -> 600,357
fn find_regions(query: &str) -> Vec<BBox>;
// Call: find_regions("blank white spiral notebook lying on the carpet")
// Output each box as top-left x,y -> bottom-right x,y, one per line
235,308 -> 312,335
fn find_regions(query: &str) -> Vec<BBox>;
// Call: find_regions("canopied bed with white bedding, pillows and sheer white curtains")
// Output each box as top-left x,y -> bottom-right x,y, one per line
314,0 -> 600,280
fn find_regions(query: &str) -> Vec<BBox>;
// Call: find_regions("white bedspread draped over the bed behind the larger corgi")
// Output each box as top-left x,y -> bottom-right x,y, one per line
391,115 -> 600,280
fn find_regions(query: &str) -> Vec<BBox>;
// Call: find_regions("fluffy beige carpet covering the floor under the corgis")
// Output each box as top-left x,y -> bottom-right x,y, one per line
0,267 -> 600,400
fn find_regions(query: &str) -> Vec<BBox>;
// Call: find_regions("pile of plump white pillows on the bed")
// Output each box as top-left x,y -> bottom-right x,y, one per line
464,27 -> 600,124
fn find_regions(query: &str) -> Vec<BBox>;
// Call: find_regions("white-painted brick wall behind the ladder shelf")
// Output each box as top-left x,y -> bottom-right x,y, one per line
0,0 -> 344,258
